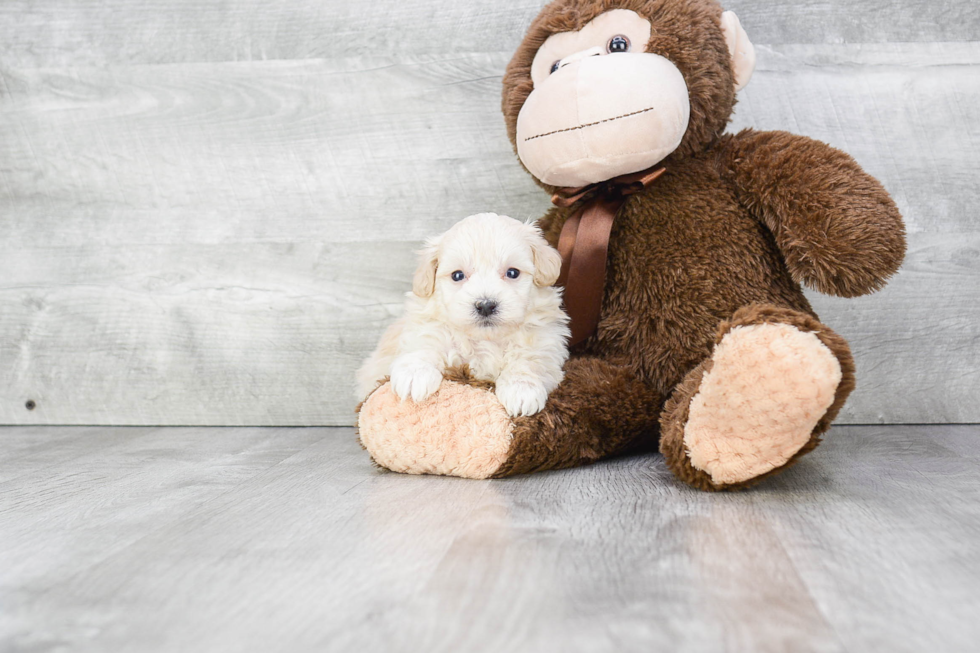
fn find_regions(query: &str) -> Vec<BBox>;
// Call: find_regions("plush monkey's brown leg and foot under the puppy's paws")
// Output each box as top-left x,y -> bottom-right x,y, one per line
358,358 -> 663,478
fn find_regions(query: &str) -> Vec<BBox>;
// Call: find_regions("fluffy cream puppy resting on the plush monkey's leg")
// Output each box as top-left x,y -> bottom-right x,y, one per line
357,213 -> 569,417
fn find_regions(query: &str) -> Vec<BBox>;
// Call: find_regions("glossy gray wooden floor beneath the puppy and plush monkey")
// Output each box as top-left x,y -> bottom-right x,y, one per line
0,426 -> 980,652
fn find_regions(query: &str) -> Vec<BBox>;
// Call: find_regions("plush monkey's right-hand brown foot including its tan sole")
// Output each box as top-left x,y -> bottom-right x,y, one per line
660,304 -> 854,490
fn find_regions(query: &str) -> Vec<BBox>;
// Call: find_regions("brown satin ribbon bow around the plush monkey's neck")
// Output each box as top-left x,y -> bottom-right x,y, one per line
551,166 -> 666,346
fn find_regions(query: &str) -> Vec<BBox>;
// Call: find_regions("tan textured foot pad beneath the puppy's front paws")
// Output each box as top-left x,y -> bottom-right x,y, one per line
358,380 -> 513,478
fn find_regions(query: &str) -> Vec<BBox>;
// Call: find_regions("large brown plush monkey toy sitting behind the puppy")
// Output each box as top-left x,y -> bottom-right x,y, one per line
358,0 -> 905,490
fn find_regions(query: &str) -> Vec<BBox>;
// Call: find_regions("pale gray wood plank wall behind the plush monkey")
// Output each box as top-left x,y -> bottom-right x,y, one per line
0,0 -> 980,425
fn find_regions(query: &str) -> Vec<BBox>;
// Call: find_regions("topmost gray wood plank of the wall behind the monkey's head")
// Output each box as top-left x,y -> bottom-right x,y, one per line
0,0 -> 980,68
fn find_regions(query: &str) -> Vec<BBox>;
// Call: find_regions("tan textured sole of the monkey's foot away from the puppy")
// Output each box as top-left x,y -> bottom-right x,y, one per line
665,323 -> 842,489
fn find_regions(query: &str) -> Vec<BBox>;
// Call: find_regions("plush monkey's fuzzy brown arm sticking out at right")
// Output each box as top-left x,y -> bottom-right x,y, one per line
720,129 -> 905,297
